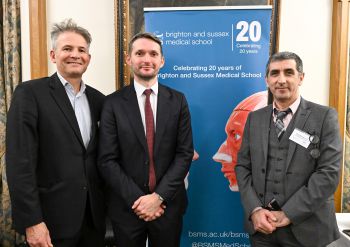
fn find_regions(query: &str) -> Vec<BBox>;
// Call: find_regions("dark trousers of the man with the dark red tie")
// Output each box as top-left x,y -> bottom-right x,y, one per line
112,213 -> 182,247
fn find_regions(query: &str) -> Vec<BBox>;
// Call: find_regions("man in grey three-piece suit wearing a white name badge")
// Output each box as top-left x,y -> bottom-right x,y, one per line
236,52 -> 342,247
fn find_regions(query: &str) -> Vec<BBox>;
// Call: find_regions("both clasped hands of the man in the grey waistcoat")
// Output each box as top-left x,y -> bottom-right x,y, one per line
251,208 -> 291,234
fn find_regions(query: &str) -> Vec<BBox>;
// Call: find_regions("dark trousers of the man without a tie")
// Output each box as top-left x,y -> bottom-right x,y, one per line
52,200 -> 105,247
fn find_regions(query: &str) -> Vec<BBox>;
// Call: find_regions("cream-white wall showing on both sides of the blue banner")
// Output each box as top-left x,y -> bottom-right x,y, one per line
21,0 -> 332,101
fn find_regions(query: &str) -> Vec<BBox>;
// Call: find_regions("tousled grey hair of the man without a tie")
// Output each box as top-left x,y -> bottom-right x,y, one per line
51,19 -> 92,49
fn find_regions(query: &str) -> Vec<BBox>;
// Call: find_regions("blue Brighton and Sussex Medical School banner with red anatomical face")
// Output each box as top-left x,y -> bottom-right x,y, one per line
145,6 -> 271,247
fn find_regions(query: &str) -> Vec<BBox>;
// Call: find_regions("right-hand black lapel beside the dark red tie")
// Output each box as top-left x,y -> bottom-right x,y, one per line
153,84 -> 170,155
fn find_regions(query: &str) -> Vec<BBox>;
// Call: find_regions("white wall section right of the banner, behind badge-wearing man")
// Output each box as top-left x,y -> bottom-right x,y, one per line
279,0 -> 333,105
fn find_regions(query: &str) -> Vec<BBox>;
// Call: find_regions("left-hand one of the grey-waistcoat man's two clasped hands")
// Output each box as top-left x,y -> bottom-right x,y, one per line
251,208 -> 277,234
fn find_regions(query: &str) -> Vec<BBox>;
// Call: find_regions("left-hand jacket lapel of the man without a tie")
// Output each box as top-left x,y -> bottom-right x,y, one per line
49,73 -> 85,148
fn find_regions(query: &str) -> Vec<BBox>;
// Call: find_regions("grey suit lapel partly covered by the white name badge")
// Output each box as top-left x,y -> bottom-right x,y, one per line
286,98 -> 311,171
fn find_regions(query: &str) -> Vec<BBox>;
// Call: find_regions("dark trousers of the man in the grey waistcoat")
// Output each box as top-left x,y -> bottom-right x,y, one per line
250,226 -> 302,247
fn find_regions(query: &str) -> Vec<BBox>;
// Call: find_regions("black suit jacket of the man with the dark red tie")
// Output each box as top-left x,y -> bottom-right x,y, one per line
98,84 -> 193,222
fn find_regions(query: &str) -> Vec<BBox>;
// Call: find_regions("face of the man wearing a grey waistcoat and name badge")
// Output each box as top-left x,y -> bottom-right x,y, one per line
265,59 -> 304,105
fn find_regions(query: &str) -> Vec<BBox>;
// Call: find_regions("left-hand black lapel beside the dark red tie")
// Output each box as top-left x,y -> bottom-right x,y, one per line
123,84 -> 148,153
